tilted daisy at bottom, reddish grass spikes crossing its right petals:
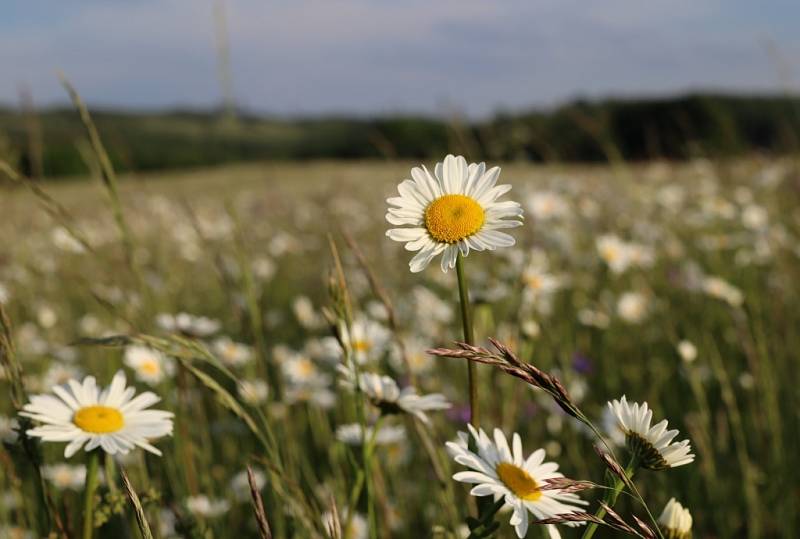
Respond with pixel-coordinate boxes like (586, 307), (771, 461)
(447, 425), (588, 537)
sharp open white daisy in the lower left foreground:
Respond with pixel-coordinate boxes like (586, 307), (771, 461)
(20, 371), (172, 458)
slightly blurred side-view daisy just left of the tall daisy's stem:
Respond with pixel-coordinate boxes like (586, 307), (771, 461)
(339, 372), (451, 424)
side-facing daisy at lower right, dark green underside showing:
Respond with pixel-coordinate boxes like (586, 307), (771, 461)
(608, 396), (694, 470)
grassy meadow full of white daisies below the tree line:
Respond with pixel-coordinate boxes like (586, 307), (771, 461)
(0, 157), (800, 539)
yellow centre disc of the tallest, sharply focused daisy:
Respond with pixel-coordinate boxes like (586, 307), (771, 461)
(425, 195), (485, 243)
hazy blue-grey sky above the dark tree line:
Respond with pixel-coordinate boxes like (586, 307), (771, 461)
(0, 0), (800, 116)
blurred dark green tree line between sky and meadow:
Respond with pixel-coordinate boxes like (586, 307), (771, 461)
(0, 94), (800, 176)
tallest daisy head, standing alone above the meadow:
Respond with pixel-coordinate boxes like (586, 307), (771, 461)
(386, 155), (522, 273)
